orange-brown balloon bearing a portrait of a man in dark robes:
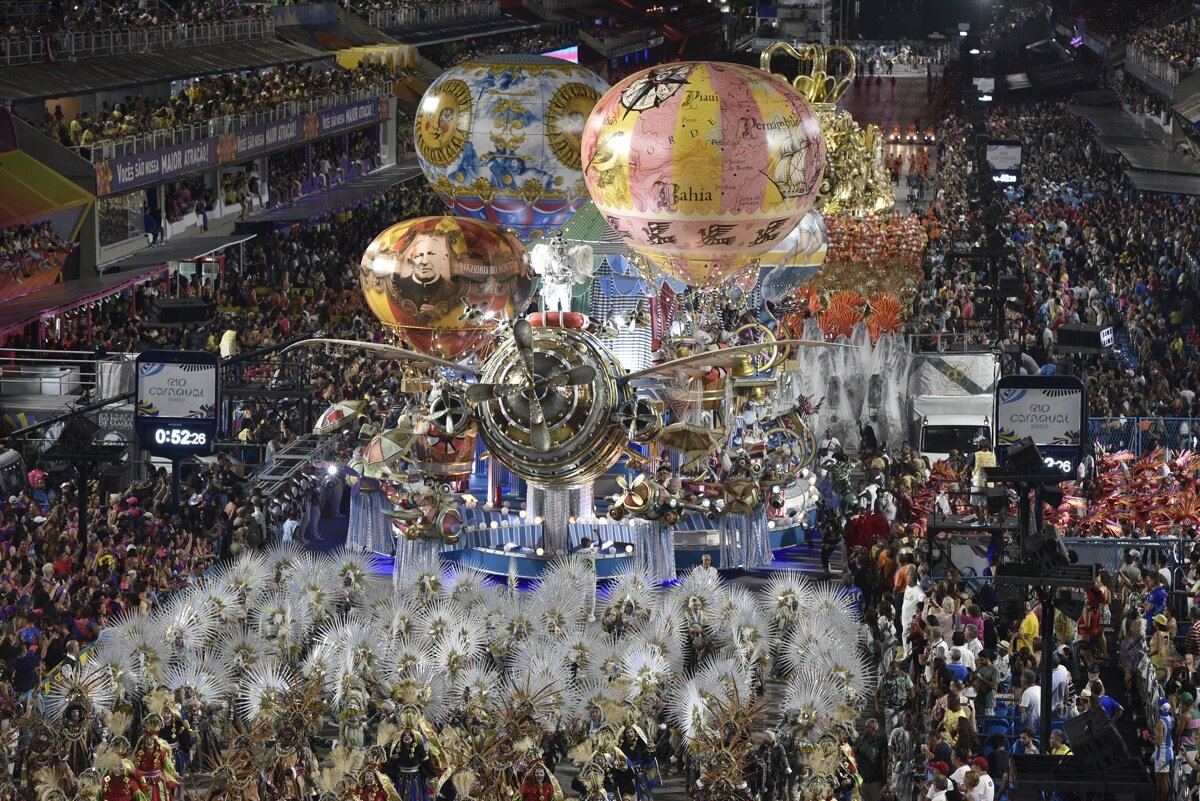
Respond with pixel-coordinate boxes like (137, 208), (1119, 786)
(359, 217), (533, 359)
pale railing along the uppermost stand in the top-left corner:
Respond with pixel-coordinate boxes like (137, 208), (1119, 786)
(0, 17), (275, 66)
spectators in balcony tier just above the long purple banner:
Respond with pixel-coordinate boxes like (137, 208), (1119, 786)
(41, 64), (401, 154)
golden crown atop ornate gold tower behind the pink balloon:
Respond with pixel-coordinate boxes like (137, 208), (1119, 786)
(760, 42), (895, 216)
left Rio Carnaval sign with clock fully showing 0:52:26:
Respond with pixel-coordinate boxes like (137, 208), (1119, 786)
(133, 350), (221, 460)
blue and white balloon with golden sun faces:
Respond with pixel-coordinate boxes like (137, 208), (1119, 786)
(413, 55), (608, 241)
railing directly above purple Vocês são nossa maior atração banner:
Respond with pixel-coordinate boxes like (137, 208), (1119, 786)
(73, 83), (392, 162)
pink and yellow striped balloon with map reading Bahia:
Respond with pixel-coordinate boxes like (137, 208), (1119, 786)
(582, 61), (826, 285)
